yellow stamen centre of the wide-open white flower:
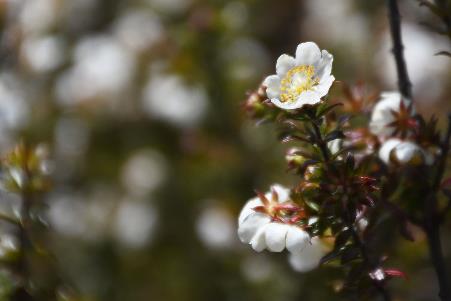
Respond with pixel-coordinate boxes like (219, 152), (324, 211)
(280, 65), (319, 102)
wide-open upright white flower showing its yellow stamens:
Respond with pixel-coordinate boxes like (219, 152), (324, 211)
(263, 42), (335, 110)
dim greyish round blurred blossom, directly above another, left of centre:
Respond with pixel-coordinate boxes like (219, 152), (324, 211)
(121, 149), (167, 196)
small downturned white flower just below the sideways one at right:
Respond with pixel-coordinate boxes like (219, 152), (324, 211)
(379, 138), (434, 165)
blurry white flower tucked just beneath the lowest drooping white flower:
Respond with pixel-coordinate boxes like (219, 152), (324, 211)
(288, 237), (327, 272)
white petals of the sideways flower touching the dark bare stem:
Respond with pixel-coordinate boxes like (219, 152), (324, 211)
(370, 92), (413, 137)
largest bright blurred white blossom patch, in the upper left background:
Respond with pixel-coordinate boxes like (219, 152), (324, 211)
(56, 36), (135, 105)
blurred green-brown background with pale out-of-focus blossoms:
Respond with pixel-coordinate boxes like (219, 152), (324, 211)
(0, 0), (451, 301)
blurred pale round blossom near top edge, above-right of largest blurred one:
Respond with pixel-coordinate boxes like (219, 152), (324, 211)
(114, 10), (164, 52)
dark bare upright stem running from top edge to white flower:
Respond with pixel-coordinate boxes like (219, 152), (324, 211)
(387, 0), (412, 99)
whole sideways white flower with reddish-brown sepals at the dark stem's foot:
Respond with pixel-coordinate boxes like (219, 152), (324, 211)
(369, 92), (414, 137)
